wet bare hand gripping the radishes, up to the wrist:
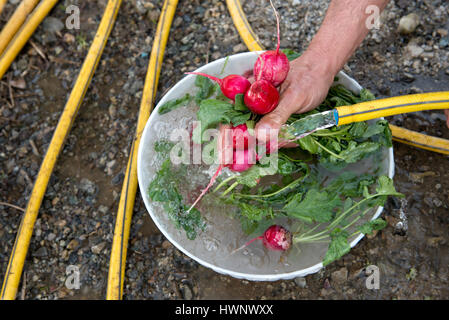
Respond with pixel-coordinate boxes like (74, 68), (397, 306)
(255, 52), (335, 141)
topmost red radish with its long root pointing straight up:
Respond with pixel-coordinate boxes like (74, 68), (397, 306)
(254, 0), (290, 87)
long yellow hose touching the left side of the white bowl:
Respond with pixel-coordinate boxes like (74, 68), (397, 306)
(106, 0), (178, 300)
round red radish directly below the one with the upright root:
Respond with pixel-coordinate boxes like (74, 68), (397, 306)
(244, 79), (279, 114)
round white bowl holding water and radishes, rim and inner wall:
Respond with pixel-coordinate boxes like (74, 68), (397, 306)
(137, 52), (394, 281)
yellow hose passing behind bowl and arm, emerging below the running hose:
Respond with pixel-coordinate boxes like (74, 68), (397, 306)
(226, 0), (449, 154)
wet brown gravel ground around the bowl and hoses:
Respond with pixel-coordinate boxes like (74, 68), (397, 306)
(0, 0), (449, 299)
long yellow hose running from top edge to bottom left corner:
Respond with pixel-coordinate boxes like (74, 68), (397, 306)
(0, 0), (122, 300)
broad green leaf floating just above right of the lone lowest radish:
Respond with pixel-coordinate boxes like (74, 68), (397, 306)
(283, 189), (341, 223)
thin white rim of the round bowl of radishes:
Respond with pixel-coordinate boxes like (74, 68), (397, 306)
(137, 51), (394, 281)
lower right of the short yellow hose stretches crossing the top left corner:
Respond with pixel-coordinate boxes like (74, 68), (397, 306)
(0, 0), (58, 79)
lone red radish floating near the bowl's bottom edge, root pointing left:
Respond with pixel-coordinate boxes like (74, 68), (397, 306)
(231, 224), (292, 254)
